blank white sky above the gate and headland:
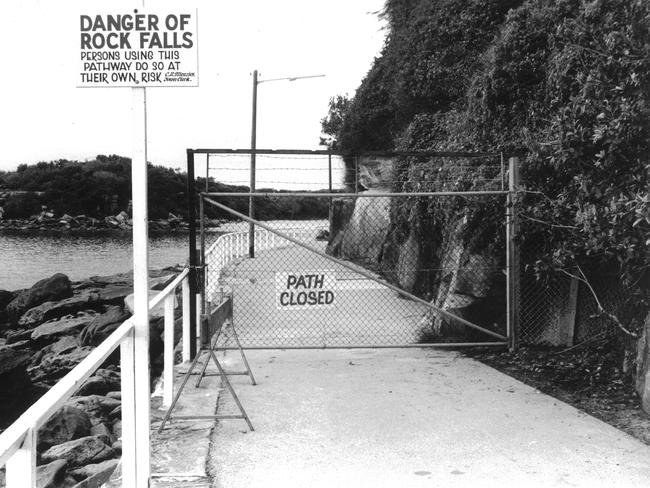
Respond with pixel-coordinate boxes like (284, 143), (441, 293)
(0, 0), (385, 185)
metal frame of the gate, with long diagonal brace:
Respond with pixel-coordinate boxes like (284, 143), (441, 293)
(187, 149), (519, 350)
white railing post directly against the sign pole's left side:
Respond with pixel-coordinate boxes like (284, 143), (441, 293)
(120, 330), (137, 488)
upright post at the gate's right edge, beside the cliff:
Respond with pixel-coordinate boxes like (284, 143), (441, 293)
(506, 158), (520, 351)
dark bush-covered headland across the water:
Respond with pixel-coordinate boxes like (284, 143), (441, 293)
(0, 155), (328, 220)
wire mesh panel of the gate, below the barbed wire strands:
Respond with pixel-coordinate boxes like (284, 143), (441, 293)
(205, 193), (506, 347)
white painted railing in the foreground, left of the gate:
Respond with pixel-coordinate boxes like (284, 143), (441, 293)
(0, 269), (190, 488)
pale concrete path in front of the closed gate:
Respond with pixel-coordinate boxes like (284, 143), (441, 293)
(210, 349), (650, 488)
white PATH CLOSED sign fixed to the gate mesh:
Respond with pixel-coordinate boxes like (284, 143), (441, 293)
(275, 270), (336, 310)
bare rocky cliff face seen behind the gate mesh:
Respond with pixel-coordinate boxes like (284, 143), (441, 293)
(327, 158), (506, 341)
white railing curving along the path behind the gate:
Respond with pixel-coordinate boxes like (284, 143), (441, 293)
(205, 227), (315, 300)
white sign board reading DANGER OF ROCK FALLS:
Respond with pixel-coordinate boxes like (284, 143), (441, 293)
(77, 7), (199, 88)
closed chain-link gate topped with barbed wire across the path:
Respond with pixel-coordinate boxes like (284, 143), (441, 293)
(194, 150), (510, 349)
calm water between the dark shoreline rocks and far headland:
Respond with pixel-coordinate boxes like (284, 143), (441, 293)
(0, 234), (195, 290)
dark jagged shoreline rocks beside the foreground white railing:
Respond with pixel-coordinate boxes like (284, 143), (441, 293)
(0, 268), (180, 488)
